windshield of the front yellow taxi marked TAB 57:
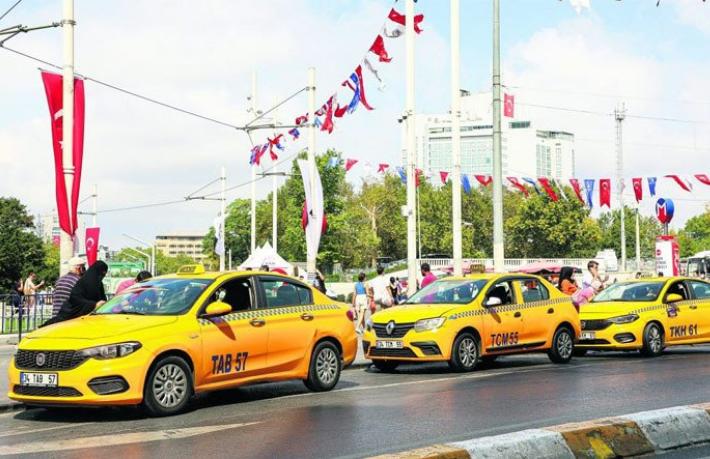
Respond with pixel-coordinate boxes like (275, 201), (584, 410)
(94, 278), (212, 316)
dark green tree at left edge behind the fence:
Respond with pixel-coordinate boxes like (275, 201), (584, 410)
(0, 197), (45, 292)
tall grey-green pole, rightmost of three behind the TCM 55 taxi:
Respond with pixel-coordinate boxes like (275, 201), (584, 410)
(493, 0), (505, 272)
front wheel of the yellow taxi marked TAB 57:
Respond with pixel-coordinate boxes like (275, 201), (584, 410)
(143, 356), (193, 417)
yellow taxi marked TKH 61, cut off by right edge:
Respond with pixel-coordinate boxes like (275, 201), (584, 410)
(578, 277), (710, 357)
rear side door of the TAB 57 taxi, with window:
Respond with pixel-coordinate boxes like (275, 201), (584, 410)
(259, 276), (319, 373)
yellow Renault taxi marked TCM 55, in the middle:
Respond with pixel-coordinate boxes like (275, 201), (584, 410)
(362, 274), (580, 371)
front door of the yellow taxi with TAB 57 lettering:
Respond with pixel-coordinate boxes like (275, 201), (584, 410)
(196, 276), (268, 385)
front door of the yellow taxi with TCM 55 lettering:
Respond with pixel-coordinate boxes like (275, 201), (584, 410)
(481, 279), (523, 353)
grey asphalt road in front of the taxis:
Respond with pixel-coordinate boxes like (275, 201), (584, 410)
(0, 346), (710, 458)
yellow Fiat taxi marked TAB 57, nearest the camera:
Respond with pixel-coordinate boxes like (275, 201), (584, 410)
(8, 265), (357, 416)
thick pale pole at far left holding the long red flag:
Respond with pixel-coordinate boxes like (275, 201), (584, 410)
(59, 0), (76, 275)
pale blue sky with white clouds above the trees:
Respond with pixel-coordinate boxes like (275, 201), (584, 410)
(0, 0), (710, 249)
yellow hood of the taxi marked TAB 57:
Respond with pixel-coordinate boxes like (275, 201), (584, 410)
(26, 314), (178, 340)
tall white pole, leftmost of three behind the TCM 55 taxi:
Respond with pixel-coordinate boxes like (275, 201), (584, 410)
(404, 0), (417, 295)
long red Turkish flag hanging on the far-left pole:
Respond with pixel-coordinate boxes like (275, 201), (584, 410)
(42, 71), (84, 236)
